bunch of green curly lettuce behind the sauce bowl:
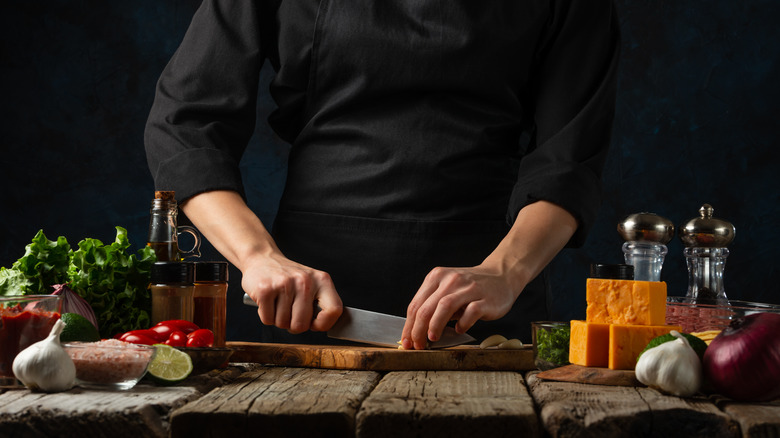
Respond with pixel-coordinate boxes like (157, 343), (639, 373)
(0, 227), (157, 338)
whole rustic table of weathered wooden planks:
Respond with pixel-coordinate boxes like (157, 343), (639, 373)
(0, 364), (780, 438)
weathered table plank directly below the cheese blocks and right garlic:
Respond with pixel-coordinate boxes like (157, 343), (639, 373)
(526, 372), (740, 438)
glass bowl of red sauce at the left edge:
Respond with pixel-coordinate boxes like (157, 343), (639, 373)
(0, 295), (62, 388)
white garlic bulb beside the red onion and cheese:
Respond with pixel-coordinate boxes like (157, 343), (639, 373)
(635, 330), (702, 397)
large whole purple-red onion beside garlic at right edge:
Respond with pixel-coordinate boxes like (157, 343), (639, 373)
(703, 313), (780, 402)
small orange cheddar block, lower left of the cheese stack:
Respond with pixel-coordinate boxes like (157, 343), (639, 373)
(569, 320), (609, 368)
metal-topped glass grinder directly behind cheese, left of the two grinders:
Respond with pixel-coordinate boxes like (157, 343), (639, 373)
(618, 212), (674, 281)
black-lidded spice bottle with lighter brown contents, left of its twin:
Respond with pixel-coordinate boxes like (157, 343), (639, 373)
(150, 262), (195, 325)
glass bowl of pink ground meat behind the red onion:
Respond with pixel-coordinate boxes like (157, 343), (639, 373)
(666, 297), (780, 333)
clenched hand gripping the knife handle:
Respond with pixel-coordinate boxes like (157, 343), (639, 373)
(241, 254), (342, 334)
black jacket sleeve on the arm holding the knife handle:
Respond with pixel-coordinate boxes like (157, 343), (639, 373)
(144, 0), (265, 202)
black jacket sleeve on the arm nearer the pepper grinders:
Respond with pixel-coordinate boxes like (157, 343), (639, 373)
(508, 0), (620, 247)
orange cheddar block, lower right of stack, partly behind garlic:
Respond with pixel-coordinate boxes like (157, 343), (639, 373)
(609, 324), (682, 370)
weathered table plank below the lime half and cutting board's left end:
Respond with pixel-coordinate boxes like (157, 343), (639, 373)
(171, 367), (380, 438)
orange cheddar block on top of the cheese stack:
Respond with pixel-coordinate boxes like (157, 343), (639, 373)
(585, 278), (666, 326)
